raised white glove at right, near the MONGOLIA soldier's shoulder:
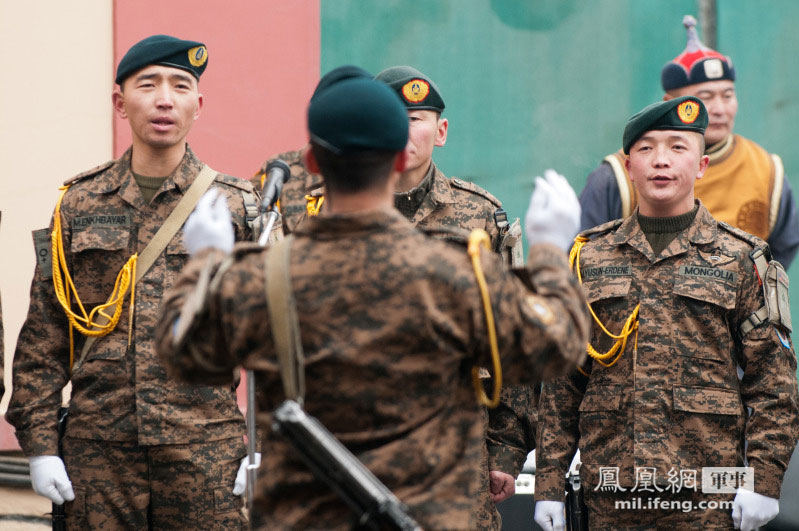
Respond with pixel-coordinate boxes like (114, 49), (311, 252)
(524, 170), (580, 252)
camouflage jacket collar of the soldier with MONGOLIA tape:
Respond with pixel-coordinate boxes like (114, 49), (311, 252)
(610, 199), (718, 262)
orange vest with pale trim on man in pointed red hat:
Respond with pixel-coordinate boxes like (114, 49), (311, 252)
(605, 135), (785, 240)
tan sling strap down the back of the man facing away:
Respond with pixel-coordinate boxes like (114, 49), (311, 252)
(264, 236), (305, 404)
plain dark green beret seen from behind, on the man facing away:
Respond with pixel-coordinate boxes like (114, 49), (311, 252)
(308, 77), (408, 154)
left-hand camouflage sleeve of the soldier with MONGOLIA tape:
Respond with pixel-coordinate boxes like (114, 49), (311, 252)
(535, 371), (588, 502)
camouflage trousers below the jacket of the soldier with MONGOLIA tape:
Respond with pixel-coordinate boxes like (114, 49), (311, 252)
(585, 490), (734, 531)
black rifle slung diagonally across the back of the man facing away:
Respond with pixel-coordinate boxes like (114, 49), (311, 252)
(272, 400), (422, 531)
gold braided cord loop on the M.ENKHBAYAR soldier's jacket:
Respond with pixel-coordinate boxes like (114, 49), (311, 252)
(50, 186), (138, 370)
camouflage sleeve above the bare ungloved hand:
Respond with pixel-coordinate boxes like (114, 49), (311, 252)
(486, 384), (540, 476)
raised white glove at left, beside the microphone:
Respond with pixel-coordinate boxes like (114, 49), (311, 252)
(183, 189), (236, 255)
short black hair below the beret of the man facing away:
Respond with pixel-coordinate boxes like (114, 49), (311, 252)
(311, 140), (398, 194)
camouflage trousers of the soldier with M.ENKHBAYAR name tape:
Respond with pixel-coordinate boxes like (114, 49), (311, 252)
(64, 437), (247, 530)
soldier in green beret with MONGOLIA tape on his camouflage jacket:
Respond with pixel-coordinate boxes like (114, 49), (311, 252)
(535, 96), (799, 530)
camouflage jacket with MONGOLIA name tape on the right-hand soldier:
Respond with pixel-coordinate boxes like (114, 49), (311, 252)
(536, 204), (799, 500)
